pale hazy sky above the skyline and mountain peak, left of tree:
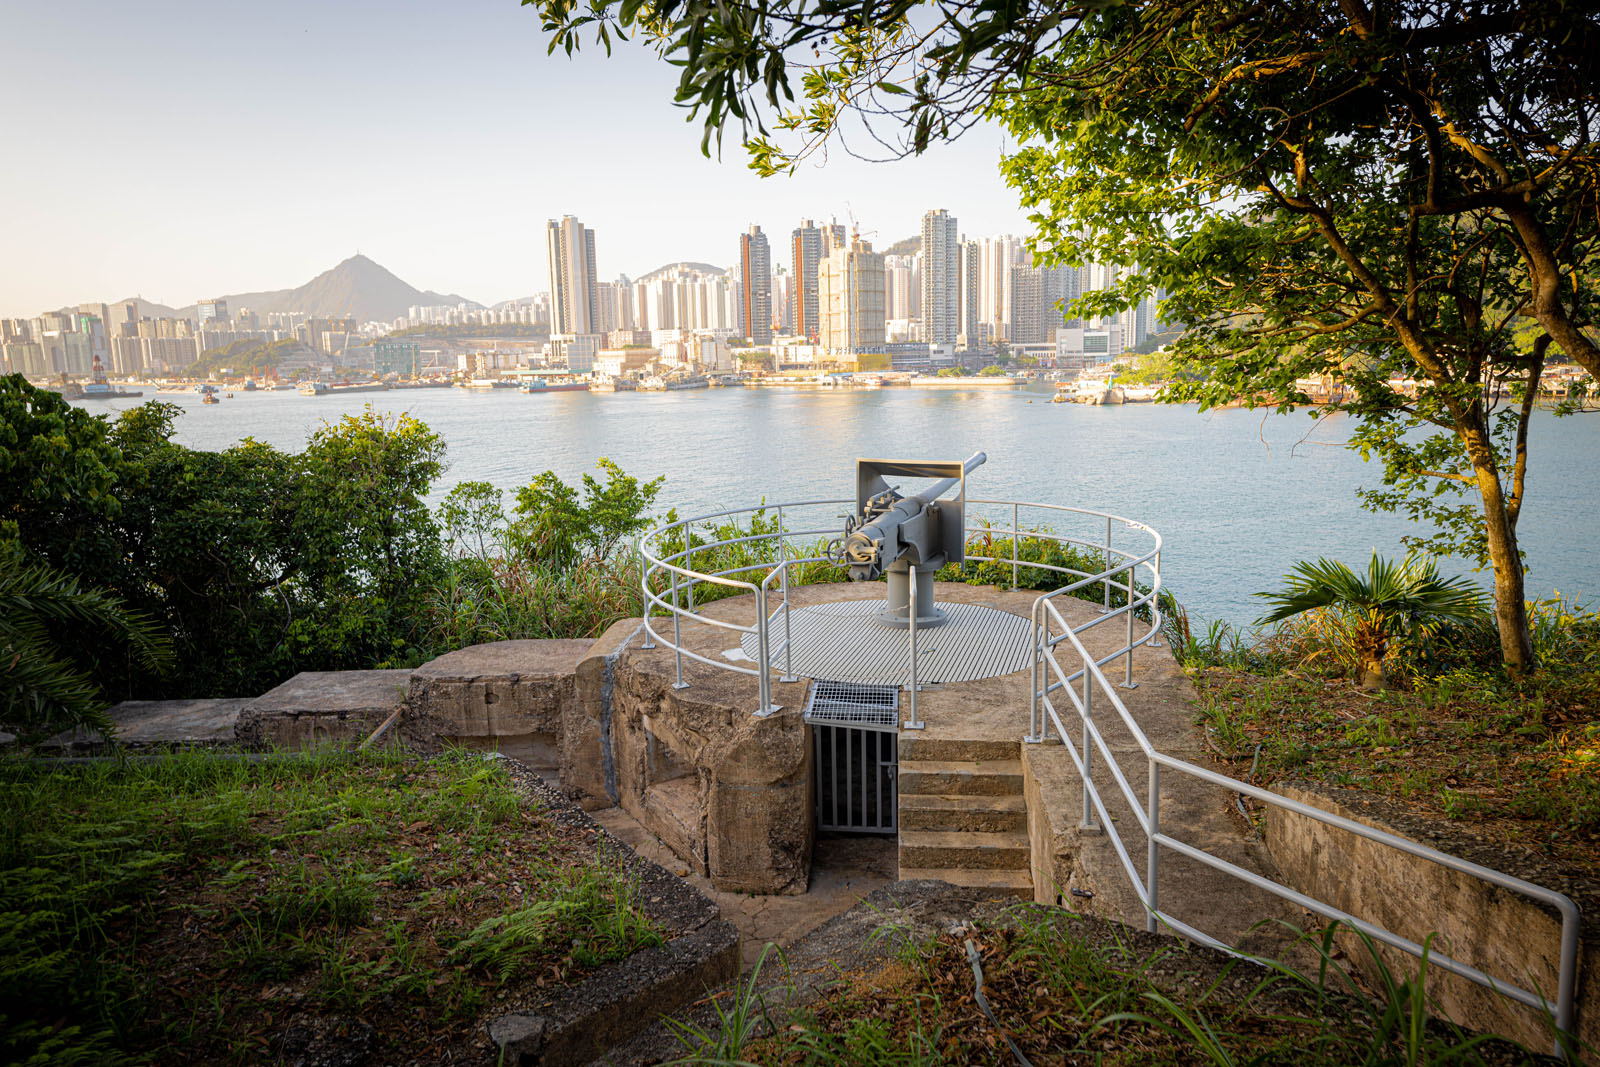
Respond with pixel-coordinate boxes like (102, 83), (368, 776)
(0, 0), (1026, 317)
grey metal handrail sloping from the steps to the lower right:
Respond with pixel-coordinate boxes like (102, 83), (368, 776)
(1026, 585), (1579, 1056)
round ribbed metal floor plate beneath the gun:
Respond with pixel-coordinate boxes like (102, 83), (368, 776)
(741, 600), (1032, 686)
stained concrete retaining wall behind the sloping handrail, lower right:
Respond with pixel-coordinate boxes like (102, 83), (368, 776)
(1266, 787), (1600, 1051)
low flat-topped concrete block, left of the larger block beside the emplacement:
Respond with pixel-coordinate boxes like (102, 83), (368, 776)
(234, 670), (411, 749)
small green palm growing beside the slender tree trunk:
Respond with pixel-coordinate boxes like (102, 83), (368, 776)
(1256, 552), (1485, 688)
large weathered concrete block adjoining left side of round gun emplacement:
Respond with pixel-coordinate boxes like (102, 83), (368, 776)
(406, 640), (592, 768)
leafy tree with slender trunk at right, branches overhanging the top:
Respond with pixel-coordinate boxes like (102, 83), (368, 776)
(530, 0), (1600, 673)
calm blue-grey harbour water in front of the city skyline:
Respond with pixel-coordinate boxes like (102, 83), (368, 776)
(82, 389), (1600, 622)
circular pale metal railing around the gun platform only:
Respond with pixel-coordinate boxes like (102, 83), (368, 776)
(637, 499), (1160, 729)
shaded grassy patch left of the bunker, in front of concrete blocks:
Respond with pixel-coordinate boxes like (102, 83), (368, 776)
(0, 753), (662, 1064)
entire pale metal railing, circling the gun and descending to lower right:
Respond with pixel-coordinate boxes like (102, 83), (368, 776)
(638, 499), (1579, 1054)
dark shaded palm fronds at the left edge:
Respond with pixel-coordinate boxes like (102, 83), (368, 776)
(0, 541), (171, 744)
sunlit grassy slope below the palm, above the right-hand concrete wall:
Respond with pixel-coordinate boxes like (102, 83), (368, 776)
(1174, 601), (1600, 865)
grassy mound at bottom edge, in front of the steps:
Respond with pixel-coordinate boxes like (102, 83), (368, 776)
(674, 905), (1574, 1067)
